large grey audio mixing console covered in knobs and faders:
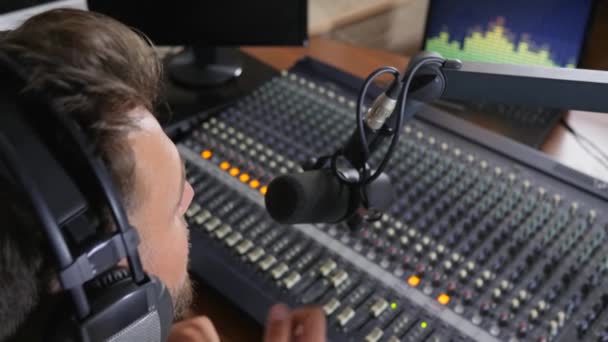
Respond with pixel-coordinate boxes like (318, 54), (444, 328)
(178, 60), (608, 341)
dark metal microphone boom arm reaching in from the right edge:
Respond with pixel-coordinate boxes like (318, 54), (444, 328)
(387, 52), (608, 132)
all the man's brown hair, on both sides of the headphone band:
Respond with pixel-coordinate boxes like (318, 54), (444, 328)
(0, 9), (161, 340)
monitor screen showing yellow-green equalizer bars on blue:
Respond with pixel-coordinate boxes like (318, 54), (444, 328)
(424, 0), (593, 67)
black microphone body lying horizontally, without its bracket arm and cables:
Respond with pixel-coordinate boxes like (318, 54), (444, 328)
(264, 168), (394, 225)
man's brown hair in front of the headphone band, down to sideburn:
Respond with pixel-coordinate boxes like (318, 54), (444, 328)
(0, 9), (161, 207)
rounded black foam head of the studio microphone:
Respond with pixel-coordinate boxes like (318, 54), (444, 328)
(264, 169), (358, 224)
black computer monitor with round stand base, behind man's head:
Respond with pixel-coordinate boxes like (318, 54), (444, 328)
(89, 0), (308, 87)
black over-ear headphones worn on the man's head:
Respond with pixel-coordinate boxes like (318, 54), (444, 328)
(0, 50), (173, 342)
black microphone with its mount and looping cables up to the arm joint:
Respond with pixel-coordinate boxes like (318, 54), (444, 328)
(264, 53), (460, 230)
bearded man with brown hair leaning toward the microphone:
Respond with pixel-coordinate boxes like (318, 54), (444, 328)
(0, 9), (325, 342)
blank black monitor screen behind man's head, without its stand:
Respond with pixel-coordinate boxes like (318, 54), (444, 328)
(89, 0), (307, 46)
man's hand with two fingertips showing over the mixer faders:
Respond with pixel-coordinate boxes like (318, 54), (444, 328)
(264, 304), (325, 342)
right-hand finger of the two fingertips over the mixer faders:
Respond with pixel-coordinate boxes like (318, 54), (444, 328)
(291, 307), (326, 342)
